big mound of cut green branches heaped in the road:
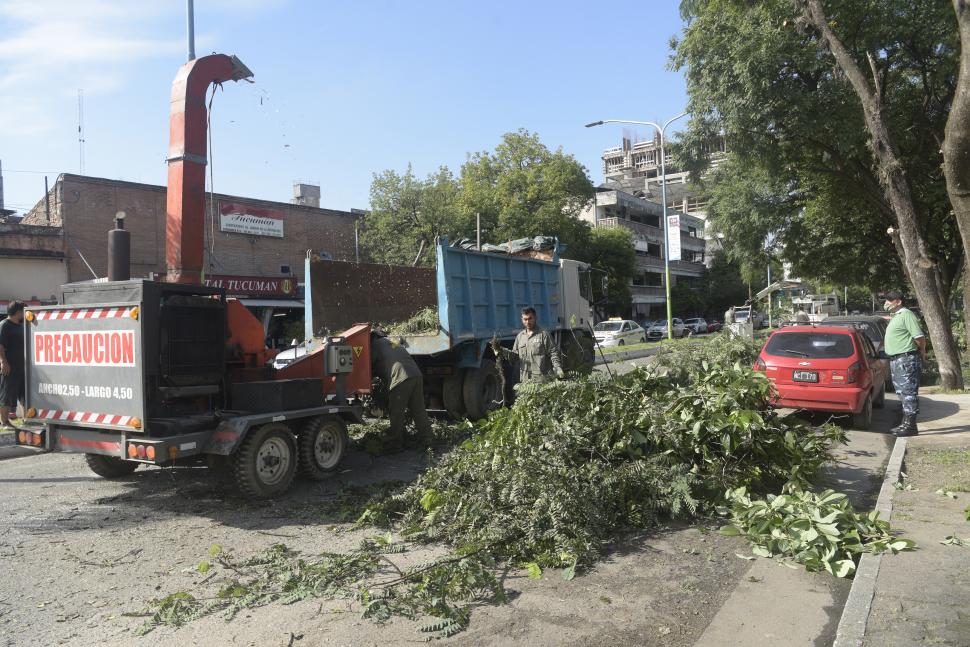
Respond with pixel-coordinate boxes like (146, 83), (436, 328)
(363, 338), (844, 569)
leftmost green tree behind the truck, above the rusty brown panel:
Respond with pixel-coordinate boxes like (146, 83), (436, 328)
(361, 164), (475, 266)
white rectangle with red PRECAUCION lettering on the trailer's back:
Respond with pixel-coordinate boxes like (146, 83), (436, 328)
(33, 330), (135, 367)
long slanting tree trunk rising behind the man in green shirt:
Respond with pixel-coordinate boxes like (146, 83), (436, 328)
(794, 0), (963, 390)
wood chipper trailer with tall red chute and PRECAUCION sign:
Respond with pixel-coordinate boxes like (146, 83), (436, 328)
(17, 54), (371, 498)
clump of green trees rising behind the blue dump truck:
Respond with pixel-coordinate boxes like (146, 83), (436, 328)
(362, 130), (636, 310)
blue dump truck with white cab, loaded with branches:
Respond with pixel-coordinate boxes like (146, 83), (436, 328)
(304, 237), (594, 420)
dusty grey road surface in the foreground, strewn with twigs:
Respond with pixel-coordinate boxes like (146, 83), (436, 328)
(0, 451), (750, 647)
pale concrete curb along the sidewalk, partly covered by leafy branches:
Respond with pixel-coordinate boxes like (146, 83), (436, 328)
(832, 438), (907, 647)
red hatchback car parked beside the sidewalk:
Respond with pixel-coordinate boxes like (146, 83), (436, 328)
(754, 325), (889, 429)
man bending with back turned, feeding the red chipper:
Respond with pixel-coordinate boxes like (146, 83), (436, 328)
(370, 333), (431, 445)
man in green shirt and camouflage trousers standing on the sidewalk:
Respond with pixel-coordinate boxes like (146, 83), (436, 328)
(885, 292), (926, 436)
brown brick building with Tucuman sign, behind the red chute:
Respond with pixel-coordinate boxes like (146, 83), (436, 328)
(23, 173), (359, 282)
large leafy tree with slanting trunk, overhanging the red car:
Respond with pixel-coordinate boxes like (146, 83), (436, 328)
(673, 0), (964, 387)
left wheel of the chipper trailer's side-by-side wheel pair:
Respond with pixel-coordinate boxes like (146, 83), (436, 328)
(232, 423), (297, 499)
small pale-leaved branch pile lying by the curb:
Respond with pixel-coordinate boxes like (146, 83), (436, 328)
(721, 487), (916, 577)
